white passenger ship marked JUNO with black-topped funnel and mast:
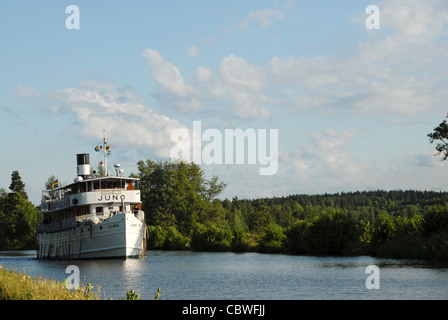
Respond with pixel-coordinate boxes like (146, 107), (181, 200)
(37, 132), (146, 259)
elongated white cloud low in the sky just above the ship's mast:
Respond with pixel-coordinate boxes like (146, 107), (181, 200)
(17, 81), (188, 158)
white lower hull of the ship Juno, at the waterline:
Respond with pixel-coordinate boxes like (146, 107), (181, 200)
(37, 213), (146, 259)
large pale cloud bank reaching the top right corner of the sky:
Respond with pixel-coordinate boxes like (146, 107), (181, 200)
(262, 0), (448, 115)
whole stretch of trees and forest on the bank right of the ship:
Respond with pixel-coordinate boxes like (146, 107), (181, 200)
(136, 160), (448, 260)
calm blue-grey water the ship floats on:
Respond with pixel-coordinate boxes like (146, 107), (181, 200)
(0, 251), (448, 300)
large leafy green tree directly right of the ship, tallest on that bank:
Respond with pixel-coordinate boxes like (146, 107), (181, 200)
(135, 160), (225, 235)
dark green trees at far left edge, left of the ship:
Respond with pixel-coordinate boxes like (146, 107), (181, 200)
(0, 171), (37, 250)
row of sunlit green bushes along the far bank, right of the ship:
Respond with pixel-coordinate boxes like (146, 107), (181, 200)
(147, 195), (448, 262)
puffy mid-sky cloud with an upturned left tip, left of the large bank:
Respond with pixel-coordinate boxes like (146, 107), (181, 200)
(143, 49), (270, 118)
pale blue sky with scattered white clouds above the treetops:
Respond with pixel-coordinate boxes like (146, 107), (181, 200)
(0, 0), (448, 204)
